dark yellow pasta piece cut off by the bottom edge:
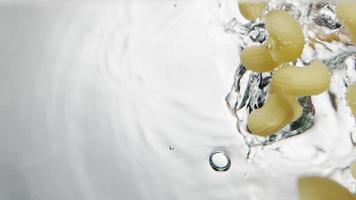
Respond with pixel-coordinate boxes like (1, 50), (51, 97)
(298, 176), (355, 200)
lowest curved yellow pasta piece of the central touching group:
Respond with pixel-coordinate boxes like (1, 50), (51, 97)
(247, 94), (294, 136)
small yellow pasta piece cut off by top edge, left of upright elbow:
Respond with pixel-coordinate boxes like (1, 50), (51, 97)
(238, 0), (267, 21)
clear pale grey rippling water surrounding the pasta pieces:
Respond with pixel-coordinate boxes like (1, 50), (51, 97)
(0, 0), (356, 200)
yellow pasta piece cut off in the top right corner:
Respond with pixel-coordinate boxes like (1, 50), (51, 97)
(336, 0), (356, 44)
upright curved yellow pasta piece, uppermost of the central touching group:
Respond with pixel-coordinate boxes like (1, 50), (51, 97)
(265, 10), (304, 63)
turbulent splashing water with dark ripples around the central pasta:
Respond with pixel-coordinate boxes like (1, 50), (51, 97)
(225, 1), (356, 148)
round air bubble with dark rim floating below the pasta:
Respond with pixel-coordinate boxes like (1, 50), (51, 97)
(209, 151), (231, 172)
